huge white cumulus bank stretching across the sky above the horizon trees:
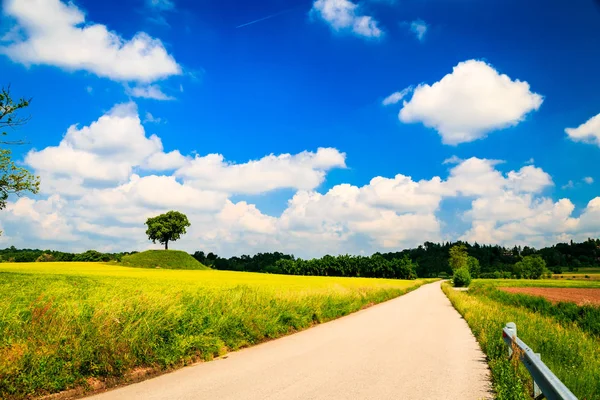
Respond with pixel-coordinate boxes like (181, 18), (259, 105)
(2, 103), (600, 257)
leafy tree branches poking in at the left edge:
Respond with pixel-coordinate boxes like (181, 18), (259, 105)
(0, 87), (40, 234)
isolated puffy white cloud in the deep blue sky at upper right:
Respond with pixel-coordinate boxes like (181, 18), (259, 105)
(399, 60), (543, 145)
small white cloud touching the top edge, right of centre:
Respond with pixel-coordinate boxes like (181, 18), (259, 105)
(311, 0), (383, 38)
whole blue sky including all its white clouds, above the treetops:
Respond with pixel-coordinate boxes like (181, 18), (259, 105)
(0, 0), (600, 256)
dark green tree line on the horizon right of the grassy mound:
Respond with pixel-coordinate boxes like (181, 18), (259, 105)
(192, 239), (600, 278)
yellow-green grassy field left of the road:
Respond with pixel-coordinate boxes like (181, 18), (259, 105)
(0, 263), (426, 399)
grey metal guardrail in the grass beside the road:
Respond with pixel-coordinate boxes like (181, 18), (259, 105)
(502, 322), (577, 400)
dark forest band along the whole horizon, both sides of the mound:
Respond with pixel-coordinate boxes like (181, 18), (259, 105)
(0, 239), (600, 279)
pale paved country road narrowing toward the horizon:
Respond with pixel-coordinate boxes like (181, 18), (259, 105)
(91, 282), (491, 400)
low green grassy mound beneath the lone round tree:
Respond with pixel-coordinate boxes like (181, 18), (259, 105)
(121, 250), (209, 269)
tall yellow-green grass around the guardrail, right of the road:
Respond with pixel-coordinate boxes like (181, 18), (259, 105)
(442, 284), (600, 400)
